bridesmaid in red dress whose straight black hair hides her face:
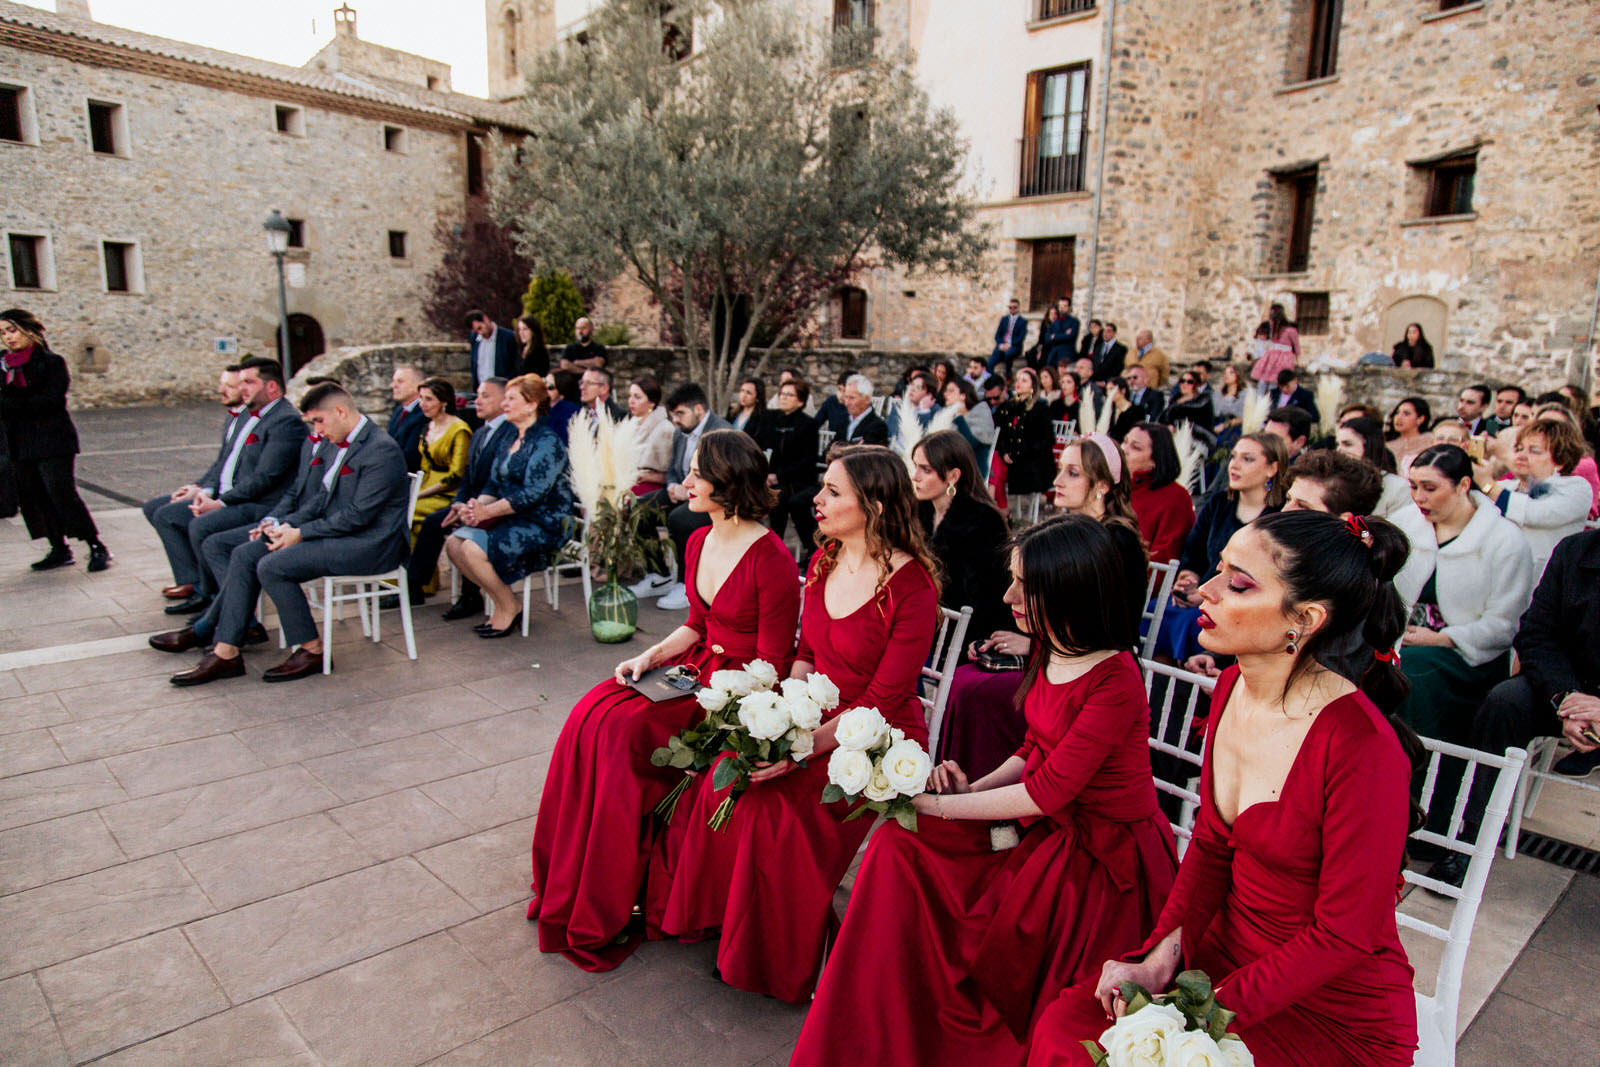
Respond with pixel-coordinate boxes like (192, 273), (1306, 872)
(790, 511), (1178, 1067)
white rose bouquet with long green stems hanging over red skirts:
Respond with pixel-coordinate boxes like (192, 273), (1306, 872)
(650, 659), (838, 830)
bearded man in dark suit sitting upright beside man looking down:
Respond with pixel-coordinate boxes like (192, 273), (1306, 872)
(157, 360), (306, 614)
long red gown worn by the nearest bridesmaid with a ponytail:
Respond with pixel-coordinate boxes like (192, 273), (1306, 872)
(1029, 667), (1416, 1067)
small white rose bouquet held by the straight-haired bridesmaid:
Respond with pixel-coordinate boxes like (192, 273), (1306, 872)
(822, 707), (933, 832)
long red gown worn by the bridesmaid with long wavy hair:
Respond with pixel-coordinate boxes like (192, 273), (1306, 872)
(645, 553), (939, 1003)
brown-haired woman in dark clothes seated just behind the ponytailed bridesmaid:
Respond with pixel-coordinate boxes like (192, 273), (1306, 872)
(1157, 434), (1290, 664)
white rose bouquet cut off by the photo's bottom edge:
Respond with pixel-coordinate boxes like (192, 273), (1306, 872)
(1083, 971), (1256, 1067)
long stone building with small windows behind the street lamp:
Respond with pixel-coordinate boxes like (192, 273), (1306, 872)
(0, 0), (515, 403)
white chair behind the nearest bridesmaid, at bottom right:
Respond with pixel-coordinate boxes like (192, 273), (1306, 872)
(1395, 737), (1528, 1067)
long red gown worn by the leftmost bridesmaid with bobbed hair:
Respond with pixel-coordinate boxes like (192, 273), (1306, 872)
(528, 526), (800, 971)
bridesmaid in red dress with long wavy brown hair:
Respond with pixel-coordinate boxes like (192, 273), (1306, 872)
(646, 445), (939, 1003)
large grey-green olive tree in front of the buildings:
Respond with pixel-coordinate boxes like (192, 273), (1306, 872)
(493, 0), (986, 406)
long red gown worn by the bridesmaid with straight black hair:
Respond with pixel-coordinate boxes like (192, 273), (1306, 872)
(790, 653), (1178, 1067)
